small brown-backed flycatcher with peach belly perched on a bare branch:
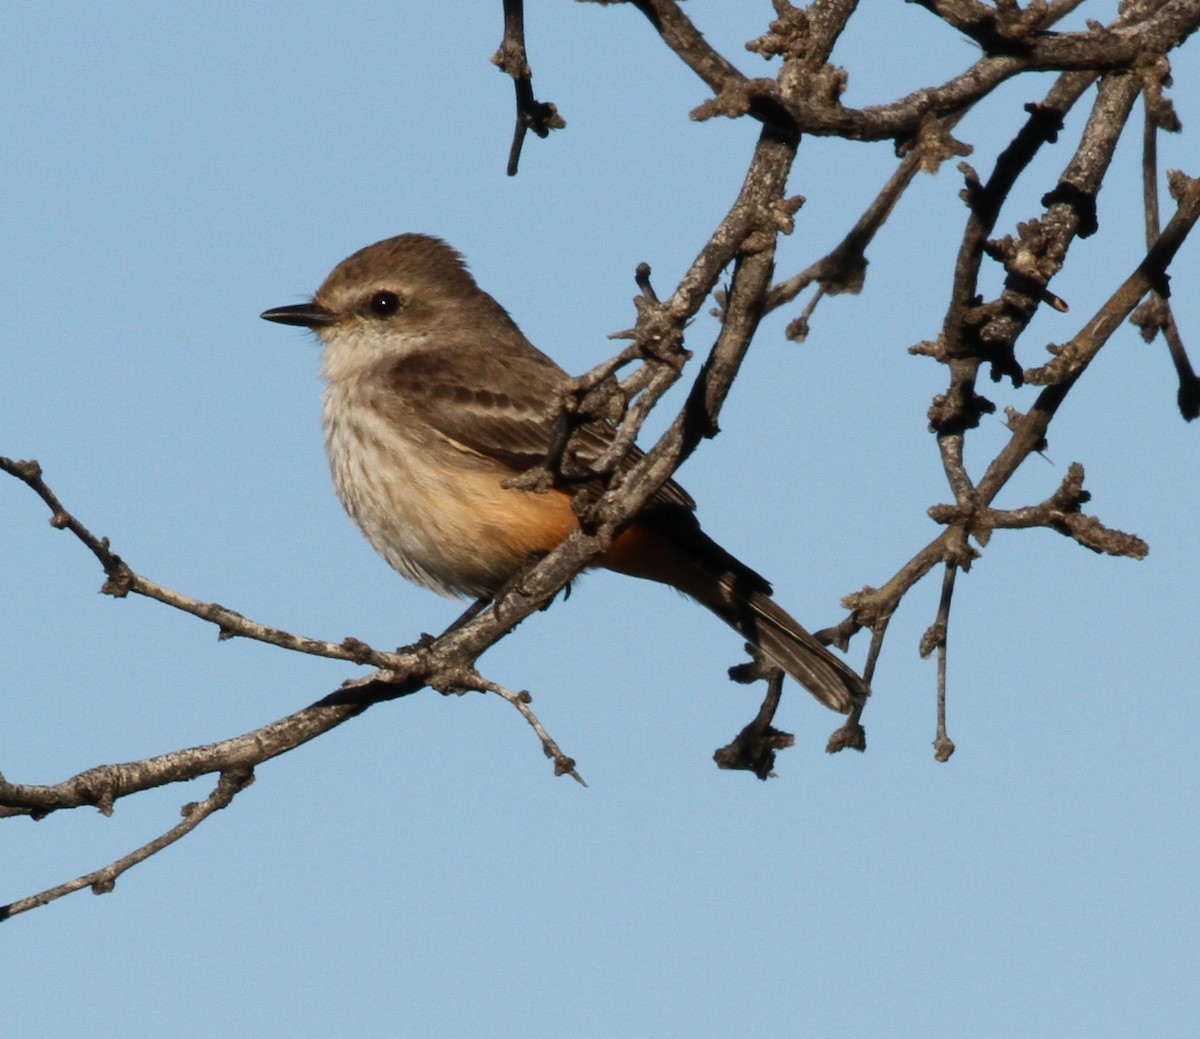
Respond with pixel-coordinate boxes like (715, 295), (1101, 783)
(263, 234), (870, 713)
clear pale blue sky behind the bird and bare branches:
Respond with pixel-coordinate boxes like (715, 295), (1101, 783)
(0, 0), (1200, 1039)
